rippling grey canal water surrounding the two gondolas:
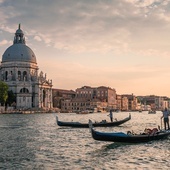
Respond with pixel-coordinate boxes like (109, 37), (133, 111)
(0, 112), (170, 170)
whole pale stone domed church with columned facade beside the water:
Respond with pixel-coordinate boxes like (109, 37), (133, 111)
(0, 24), (52, 110)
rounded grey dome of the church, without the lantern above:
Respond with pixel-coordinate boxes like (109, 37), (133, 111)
(2, 44), (37, 63)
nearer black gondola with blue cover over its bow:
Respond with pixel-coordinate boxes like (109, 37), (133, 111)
(89, 119), (170, 143)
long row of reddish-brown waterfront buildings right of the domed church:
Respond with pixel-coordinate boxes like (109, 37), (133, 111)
(53, 86), (170, 112)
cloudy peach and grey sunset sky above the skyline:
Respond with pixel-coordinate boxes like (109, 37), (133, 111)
(0, 0), (170, 97)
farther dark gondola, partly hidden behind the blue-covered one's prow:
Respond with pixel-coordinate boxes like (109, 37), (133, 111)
(56, 114), (131, 128)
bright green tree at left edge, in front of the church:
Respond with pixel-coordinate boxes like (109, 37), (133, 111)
(0, 81), (8, 105)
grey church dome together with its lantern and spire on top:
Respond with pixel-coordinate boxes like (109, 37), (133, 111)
(2, 25), (37, 63)
